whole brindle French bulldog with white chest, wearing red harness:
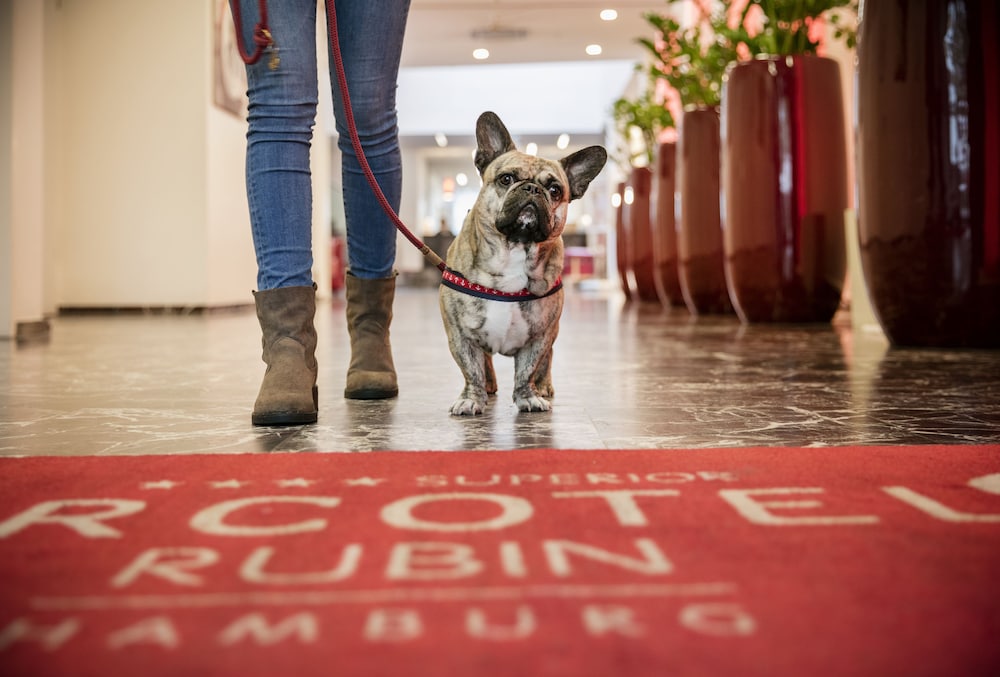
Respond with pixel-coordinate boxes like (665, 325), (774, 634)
(439, 112), (608, 416)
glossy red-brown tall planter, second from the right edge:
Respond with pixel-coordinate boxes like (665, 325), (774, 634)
(722, 55), (848, 322)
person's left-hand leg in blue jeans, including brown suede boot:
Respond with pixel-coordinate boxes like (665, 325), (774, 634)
(233, 0), (317, 425)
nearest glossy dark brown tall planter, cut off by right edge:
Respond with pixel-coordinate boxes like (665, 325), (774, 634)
(857, 0), (1000, 348)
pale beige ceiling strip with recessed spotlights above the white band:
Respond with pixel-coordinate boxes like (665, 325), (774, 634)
(403, 0), (666, 68)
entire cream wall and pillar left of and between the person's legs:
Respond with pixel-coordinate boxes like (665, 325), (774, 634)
(0, 0), (300, 322)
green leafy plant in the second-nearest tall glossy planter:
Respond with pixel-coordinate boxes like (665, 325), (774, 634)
(740, 0), (858, 55)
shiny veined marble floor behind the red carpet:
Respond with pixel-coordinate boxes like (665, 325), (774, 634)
(0, 288), (1000, 455)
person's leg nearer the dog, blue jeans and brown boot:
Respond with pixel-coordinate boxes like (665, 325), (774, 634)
(330, 0), (409, 399)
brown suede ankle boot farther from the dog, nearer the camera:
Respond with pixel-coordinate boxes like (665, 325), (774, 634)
(251, 284), (318, 425)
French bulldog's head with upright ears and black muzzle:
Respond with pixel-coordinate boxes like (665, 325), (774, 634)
(476, 113), (607, 244)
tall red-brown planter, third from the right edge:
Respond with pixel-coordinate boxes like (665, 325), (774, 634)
(677, 107), (733, 315)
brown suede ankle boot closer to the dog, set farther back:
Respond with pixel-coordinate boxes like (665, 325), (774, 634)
(344, 273), (399, 400)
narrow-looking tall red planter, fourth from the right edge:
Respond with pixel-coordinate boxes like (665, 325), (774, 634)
(650, 142), (684, 309)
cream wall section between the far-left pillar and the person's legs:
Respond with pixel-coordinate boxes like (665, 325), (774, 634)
(49, 0), (253, 307)
